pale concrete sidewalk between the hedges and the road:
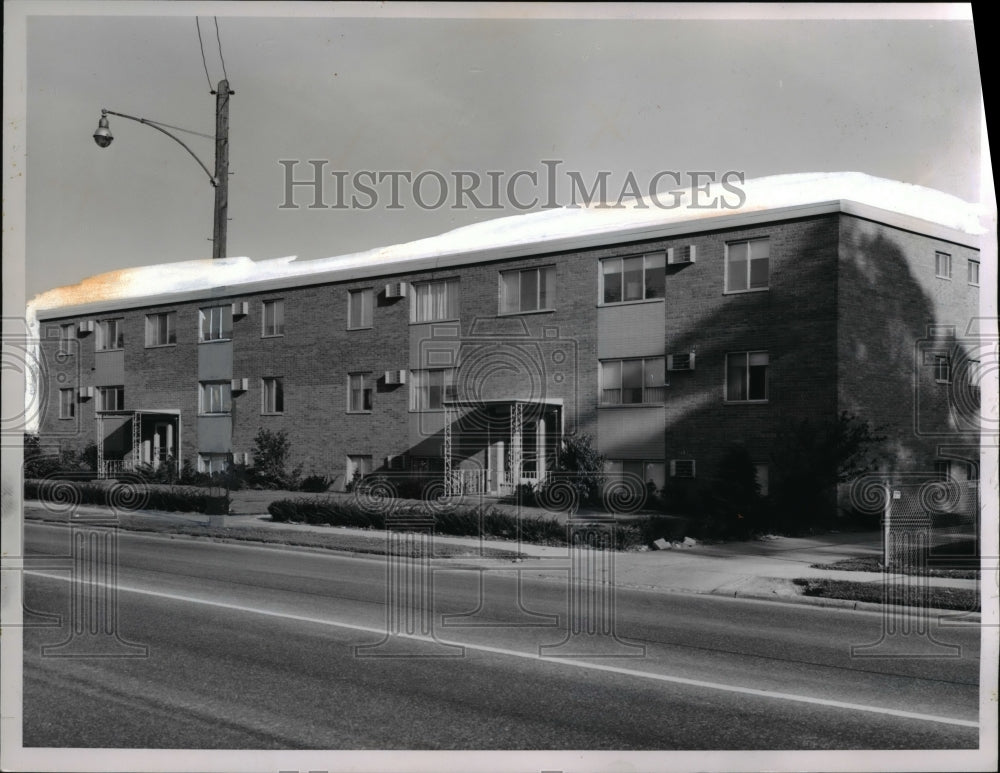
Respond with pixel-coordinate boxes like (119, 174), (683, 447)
(47, 508), (979, 606)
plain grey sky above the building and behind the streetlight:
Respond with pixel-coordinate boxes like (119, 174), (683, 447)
(5, 2), (981, 299)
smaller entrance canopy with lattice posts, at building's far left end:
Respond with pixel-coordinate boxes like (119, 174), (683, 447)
(96, 408), (181, 478)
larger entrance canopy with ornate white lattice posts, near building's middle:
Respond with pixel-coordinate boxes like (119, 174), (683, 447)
(443, 400), (563, 496)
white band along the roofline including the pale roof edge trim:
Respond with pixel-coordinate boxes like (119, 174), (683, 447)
(28, 172), (985, 319)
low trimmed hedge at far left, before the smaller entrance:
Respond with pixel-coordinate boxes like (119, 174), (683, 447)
(24, 479), (229, 514)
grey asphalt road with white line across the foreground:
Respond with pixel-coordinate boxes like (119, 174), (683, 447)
(17, 522), (979, 750)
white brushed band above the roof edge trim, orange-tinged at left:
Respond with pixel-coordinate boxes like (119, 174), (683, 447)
(28, 172), (985, 319)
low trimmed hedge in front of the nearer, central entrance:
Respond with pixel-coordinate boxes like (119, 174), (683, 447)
(267, 498), (645, 550)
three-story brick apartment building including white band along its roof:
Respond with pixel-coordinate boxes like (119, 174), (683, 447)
(31, 174), (979, 516)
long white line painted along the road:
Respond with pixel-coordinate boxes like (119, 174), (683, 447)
(24, 570), (979, 728)
